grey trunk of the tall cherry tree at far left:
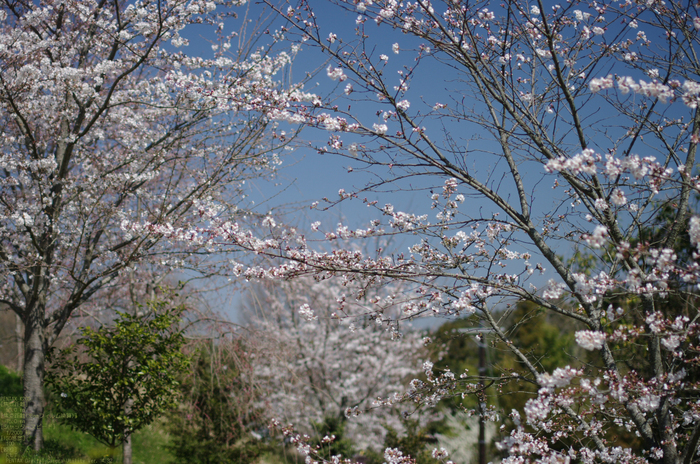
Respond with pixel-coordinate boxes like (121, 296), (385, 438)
(24, 304), (46, 451)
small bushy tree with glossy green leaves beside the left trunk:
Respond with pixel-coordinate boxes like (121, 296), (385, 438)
(46, 300), (189, 447)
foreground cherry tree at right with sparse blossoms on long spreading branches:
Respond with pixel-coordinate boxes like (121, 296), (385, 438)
(194, 0), (700, 464)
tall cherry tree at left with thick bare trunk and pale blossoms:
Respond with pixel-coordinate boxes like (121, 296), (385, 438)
(0, 0), (308, 449)
